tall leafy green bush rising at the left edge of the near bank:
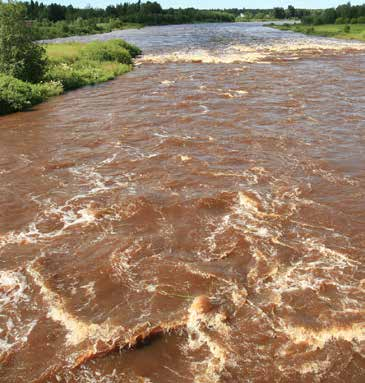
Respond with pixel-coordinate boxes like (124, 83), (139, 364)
(0, 2), (47, 82)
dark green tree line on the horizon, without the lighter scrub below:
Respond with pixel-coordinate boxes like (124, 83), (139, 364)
(14, 0), (365, 25)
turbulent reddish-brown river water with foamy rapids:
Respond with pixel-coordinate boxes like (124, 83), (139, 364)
(0, 23), (365, 383)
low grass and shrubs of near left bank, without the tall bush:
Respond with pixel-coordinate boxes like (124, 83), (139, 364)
(0, 39), (141, 115)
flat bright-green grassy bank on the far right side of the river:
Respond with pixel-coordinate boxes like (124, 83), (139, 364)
(269, 24), (365, 41)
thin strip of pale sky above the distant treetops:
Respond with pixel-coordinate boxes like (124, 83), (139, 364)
(35, 0), (365, 9)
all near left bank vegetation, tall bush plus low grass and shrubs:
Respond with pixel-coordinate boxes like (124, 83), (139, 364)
(0, 2), (141, 115)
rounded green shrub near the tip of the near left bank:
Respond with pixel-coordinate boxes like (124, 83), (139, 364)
(81, 40), (132, 64)
